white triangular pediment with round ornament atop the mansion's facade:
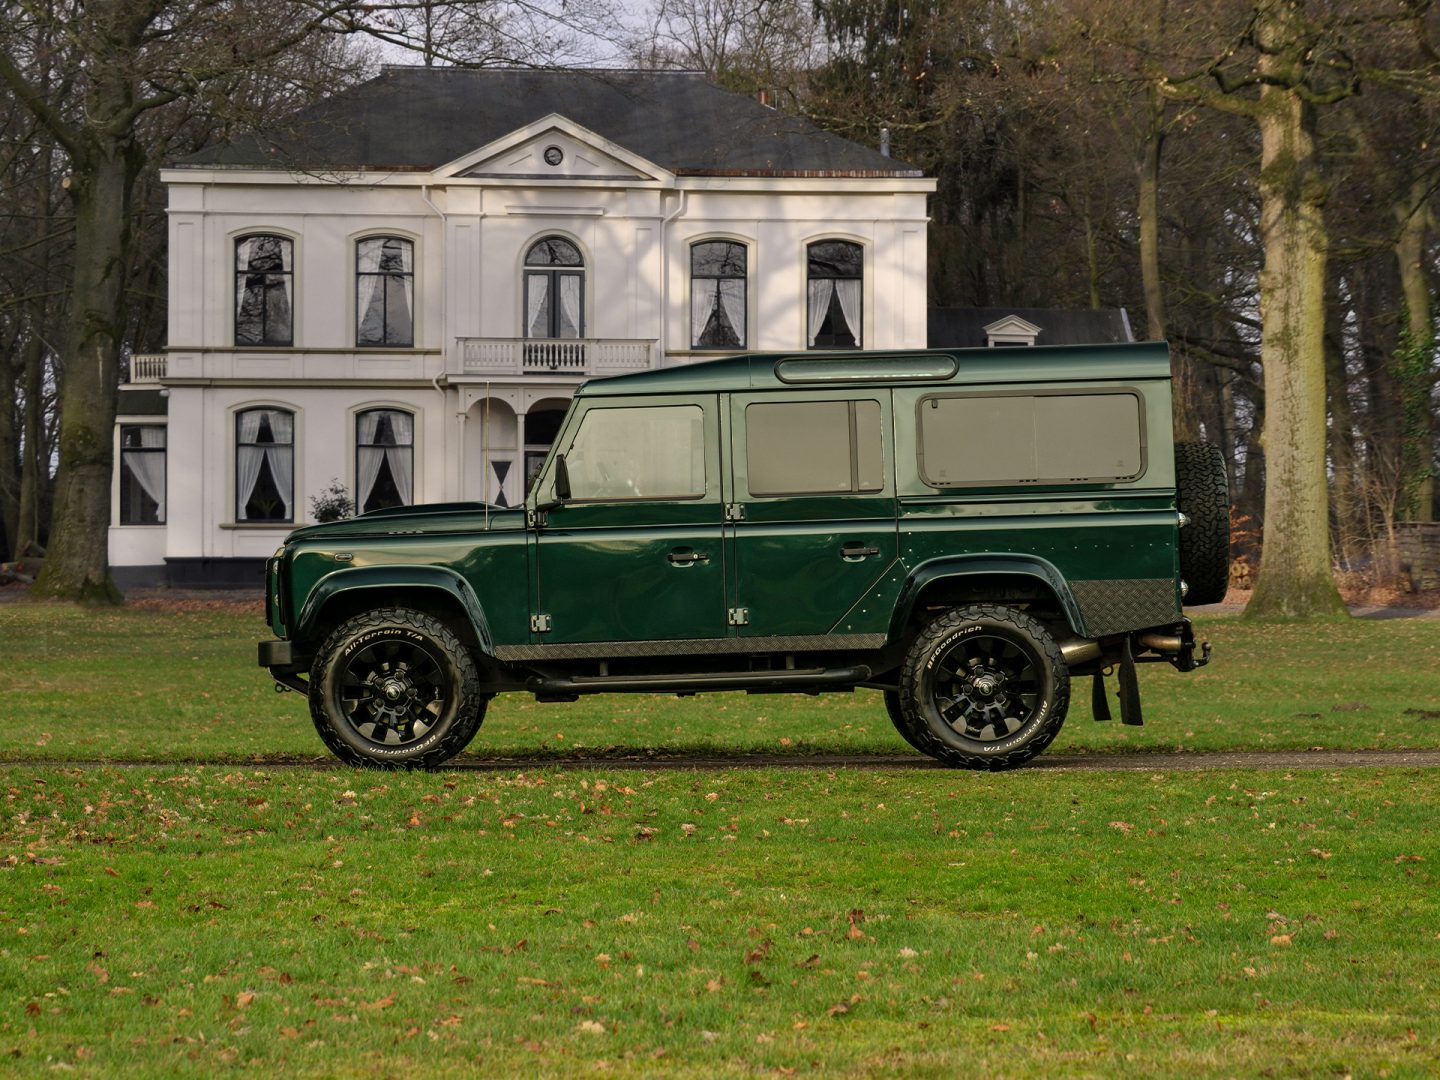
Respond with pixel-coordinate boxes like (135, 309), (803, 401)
(438, 112), (674, 184)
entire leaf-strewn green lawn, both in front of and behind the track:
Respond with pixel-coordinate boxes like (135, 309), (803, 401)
(0, 603), (1440, 1077)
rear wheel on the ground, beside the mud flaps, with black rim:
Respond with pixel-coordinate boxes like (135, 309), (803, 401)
(899, 603), (1070, 770)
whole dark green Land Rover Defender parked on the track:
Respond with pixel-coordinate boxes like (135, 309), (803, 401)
(259, 344), (1230, 769)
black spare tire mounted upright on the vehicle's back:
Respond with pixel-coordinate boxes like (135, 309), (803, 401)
(1175, 442), (1230, 603)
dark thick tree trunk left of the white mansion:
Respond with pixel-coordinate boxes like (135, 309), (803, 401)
(35, 137), (141, 603)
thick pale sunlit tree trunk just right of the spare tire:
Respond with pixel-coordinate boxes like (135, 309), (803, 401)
(1246, 78), (1345, 616)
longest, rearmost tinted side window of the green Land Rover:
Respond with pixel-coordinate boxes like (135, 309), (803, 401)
(919, 390), (1145, 488)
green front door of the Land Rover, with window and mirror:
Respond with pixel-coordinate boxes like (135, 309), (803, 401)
(531, 395), (727, 645)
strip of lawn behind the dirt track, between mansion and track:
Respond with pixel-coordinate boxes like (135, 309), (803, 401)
(0, 603), (1440, 760)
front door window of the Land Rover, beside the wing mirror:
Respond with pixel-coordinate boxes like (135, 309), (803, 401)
(564, 405), (706, 501)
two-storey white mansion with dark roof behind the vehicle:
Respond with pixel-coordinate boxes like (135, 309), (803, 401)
(118, 68), (935, 585)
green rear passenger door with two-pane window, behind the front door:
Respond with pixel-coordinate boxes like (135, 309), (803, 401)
(730, 390), (899, 636)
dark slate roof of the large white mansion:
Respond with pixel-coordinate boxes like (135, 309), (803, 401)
(177, 68), (920, 177)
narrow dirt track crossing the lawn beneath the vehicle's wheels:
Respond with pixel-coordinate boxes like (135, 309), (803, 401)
(8, 750), (1440, 773)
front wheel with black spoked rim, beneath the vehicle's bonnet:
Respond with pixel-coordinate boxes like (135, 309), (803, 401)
(310, 608), (490, 769)
